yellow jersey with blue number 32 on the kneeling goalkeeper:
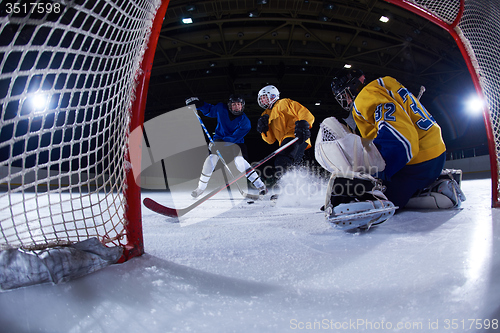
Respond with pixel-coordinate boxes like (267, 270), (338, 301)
(352, 76), (446, 177)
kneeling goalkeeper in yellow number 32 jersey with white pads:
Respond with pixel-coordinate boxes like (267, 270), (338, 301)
(315, 69), (465, 229)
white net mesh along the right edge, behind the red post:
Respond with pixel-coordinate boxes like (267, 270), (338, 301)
(400, 0), (500, 205)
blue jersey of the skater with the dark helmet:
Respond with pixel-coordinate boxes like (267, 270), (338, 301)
(198, 103), (252, 143)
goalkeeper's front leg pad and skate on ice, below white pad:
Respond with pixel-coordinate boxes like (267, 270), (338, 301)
(324, 172), (398, 230)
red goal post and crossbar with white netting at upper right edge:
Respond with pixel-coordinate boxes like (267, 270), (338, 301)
(386, 0), (500, 207)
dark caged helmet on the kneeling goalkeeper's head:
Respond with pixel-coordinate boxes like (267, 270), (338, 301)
(332, 69), (365, 111)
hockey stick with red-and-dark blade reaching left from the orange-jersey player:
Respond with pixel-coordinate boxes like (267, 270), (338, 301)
(143, 138), (298, 217)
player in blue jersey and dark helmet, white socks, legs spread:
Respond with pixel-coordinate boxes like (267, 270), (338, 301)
(186, 94), (267, 198)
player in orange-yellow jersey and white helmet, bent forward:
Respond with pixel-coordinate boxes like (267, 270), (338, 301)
(257, 85), (314, 182)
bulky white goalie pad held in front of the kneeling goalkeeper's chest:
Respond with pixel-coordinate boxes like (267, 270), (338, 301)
(314, 117), (385, 174)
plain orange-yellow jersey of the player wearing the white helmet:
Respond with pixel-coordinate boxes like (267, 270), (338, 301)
(262, 98), (314, 149)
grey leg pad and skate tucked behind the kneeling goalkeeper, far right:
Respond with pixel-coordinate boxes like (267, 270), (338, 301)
(405, 169), (466, 209)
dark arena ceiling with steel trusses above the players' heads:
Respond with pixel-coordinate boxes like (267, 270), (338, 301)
(145, 0), (480, 154)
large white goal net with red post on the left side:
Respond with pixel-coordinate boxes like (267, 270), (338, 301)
(0, 0), (168, 260)
